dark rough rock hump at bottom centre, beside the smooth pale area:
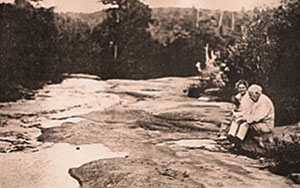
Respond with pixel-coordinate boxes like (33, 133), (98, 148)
(69, 159), (205, 188)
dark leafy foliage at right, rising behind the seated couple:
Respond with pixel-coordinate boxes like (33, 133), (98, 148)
(227, 0), (300, 124)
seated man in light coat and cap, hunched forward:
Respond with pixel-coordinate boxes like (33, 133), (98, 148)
(228, 85), (275, 145)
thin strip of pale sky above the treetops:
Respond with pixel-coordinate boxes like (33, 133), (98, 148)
(0, 0), (280, 13)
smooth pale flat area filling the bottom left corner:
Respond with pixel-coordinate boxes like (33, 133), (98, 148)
(0, 143), (127, 188)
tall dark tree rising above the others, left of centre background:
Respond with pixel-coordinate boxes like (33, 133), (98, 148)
(92, 0), (159, 78)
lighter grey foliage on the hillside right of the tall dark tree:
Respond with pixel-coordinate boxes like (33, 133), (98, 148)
(149, 8), (251, 45)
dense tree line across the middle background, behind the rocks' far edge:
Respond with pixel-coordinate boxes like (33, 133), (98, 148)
(53, 3), (249, 79)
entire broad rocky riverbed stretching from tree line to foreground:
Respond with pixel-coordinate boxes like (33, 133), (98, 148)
(0, 75), (299, 188)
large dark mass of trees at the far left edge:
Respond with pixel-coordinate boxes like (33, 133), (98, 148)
(0, 1), (59, 91)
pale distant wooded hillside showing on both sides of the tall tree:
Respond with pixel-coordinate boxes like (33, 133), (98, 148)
(59, 8), (252, 39)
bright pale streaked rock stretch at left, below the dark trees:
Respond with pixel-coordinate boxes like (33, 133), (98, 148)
(0, 75), (119, 153)
